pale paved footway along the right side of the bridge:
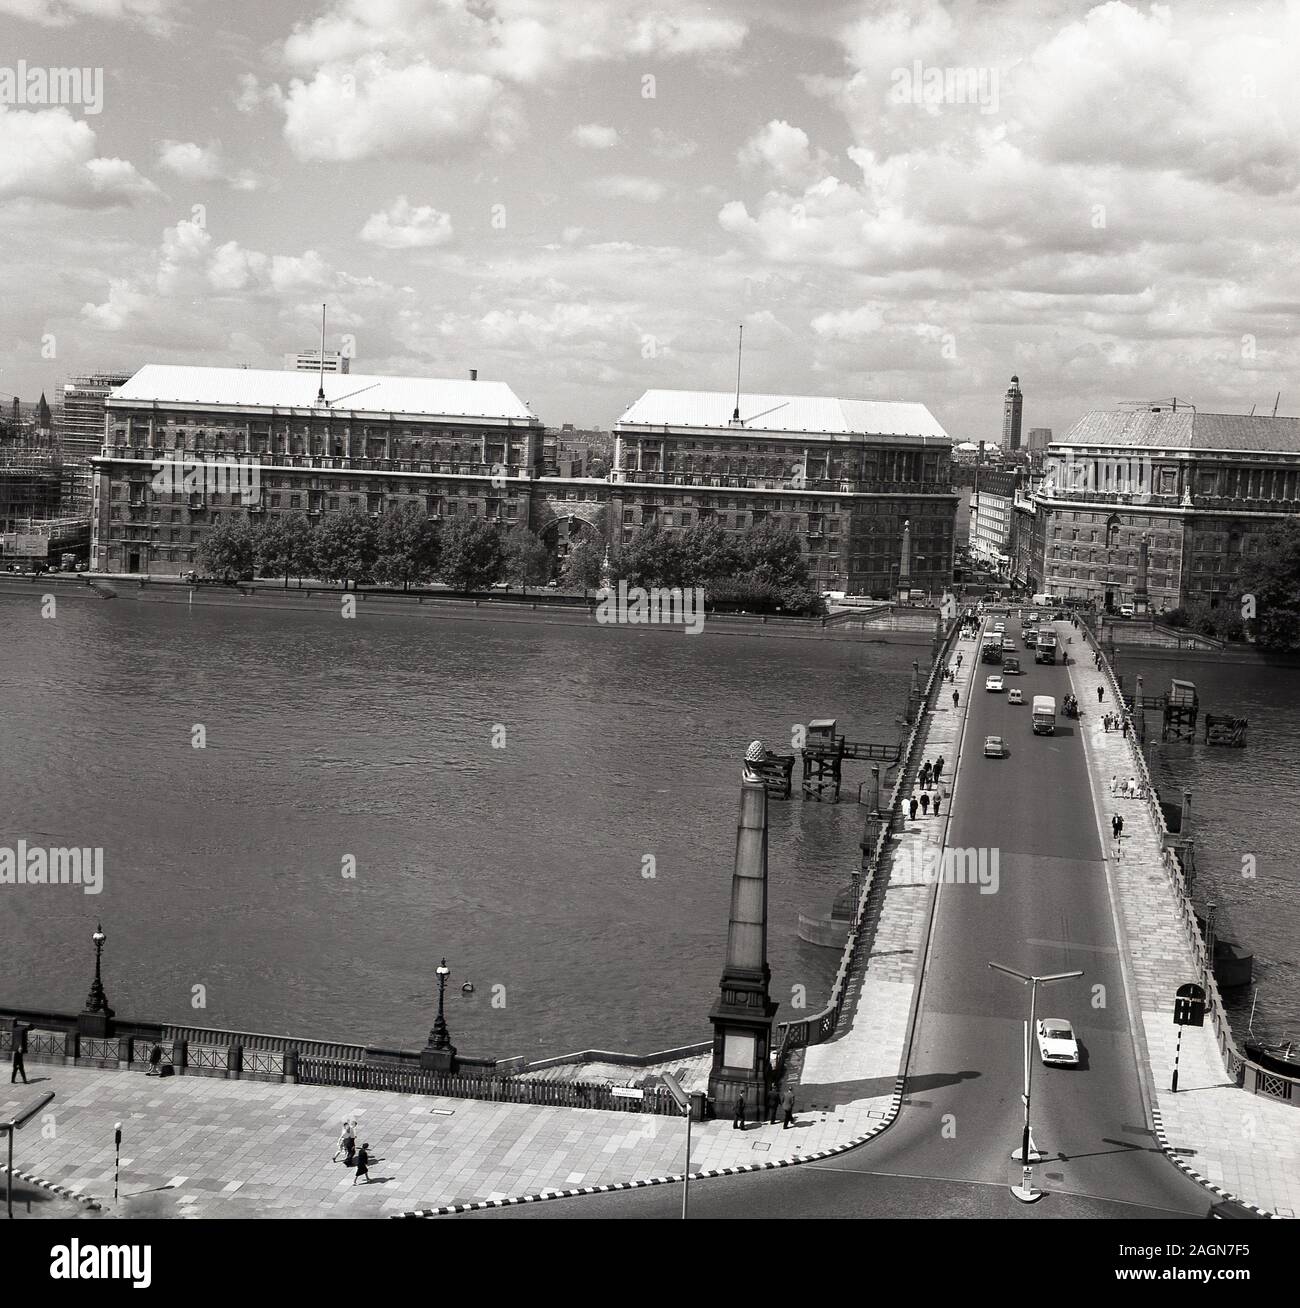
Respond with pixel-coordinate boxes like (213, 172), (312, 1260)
(1055, 623), (1300, 1218)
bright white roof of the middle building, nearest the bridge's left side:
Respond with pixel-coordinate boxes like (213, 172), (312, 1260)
(617, 391), (948, 441)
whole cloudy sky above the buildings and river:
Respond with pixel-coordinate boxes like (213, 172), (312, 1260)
(0, 0), (1300, 439)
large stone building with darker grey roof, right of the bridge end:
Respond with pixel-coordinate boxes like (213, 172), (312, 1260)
(1035, 404), (1300, 611)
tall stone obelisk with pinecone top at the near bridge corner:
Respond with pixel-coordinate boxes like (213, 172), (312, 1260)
(709, 740), (777, 1120)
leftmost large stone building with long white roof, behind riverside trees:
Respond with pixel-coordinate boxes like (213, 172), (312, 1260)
(92, 364), (553, 574)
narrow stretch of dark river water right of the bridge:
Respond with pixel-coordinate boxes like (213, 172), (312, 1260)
(1117, 659), (1300, 1039)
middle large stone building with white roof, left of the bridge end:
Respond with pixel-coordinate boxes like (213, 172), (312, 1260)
(611, 390), (957, 595)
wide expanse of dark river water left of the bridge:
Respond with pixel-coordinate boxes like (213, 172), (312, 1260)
(0, 594), (922, 1057)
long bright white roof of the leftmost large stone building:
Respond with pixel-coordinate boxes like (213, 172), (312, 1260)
(109, 364), (536, 421)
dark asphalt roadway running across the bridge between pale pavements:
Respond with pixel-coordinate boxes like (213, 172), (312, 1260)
(455, 620), (1211, 1218)
